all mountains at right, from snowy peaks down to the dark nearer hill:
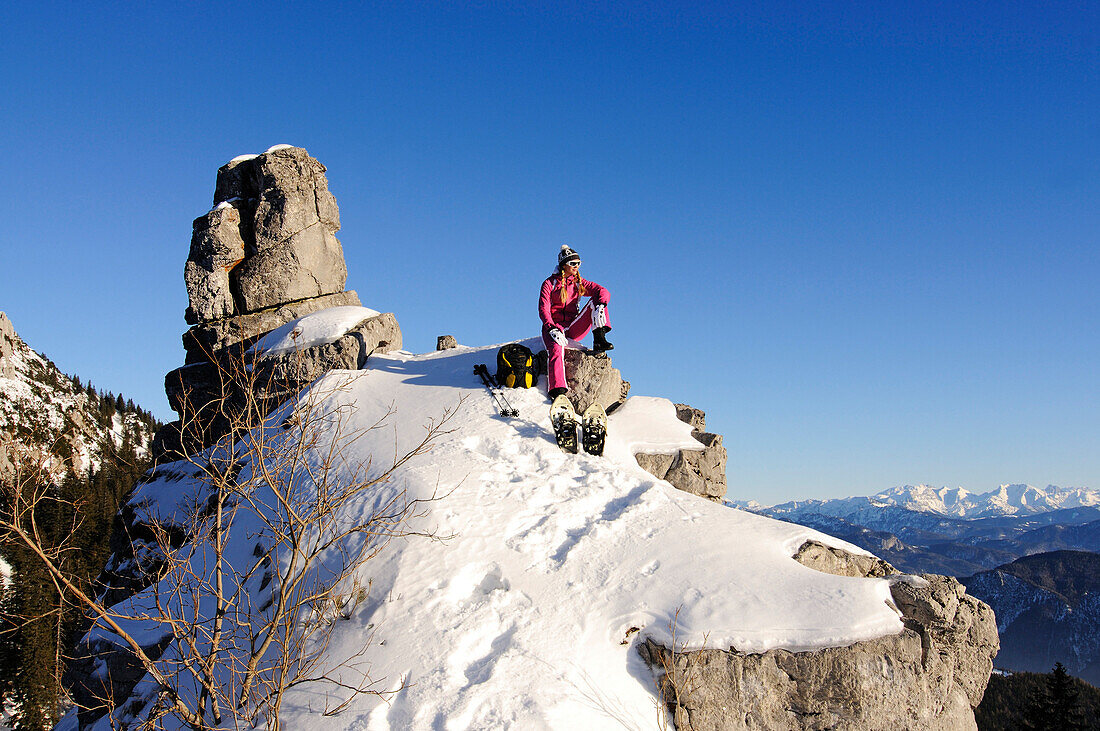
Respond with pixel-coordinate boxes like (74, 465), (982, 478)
(735, 485), (1100, 684)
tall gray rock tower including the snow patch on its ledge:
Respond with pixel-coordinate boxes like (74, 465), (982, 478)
(165, 145), (385, 454)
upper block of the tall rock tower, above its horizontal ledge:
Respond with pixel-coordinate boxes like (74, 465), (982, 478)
(185, 147), (348, 324)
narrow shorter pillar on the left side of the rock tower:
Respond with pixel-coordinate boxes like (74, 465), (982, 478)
(184, 203), (244, 324)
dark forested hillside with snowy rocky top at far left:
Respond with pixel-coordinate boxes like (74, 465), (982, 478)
(0, 312), (160, 729)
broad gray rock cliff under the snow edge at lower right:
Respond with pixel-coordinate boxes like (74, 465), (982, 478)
(638, 543), (998, 731)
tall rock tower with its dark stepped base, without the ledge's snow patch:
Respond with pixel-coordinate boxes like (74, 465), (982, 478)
(154, 145), (402, 458)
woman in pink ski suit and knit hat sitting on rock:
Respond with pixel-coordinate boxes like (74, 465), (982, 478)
(539, 245), (614, 399)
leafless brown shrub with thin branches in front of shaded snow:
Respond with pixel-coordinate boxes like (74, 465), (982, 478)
(0, 352), (454, 730)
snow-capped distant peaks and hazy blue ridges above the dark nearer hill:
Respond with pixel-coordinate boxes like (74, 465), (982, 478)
(734, 485), (1100, 576)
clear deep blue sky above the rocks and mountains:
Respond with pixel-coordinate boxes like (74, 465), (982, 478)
(0, 2), (1100, 502)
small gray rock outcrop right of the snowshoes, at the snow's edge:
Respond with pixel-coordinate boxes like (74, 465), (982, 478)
(635, 403), (727, 501)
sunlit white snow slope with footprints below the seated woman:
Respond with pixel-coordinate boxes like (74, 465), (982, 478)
(73, 346), (902, 730)
